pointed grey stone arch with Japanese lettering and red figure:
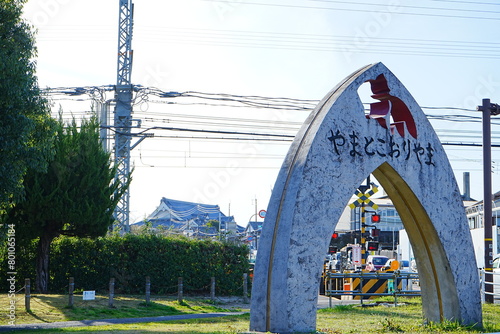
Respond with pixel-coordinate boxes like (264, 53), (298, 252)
(250, 63), (482, 333)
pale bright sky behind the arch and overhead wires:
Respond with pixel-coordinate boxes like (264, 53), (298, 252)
(20, 0), (500, 226)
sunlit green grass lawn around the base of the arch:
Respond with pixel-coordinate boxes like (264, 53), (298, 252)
(0, 295), (500, 334)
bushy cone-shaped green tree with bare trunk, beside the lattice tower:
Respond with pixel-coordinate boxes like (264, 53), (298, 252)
(8, 117), (128, 292)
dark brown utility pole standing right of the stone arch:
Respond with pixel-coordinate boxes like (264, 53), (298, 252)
(477, 99), (500, 303)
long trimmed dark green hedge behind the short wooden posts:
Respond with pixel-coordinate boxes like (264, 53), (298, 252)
(2, 235), (249, 295)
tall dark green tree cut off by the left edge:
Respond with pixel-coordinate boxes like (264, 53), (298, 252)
(0, 0), (54, 211)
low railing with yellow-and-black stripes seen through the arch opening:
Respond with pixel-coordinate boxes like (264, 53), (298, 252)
(324, 270), (420, 305)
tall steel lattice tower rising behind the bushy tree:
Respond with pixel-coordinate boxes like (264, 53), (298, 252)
(114, 0), (134, 232)
